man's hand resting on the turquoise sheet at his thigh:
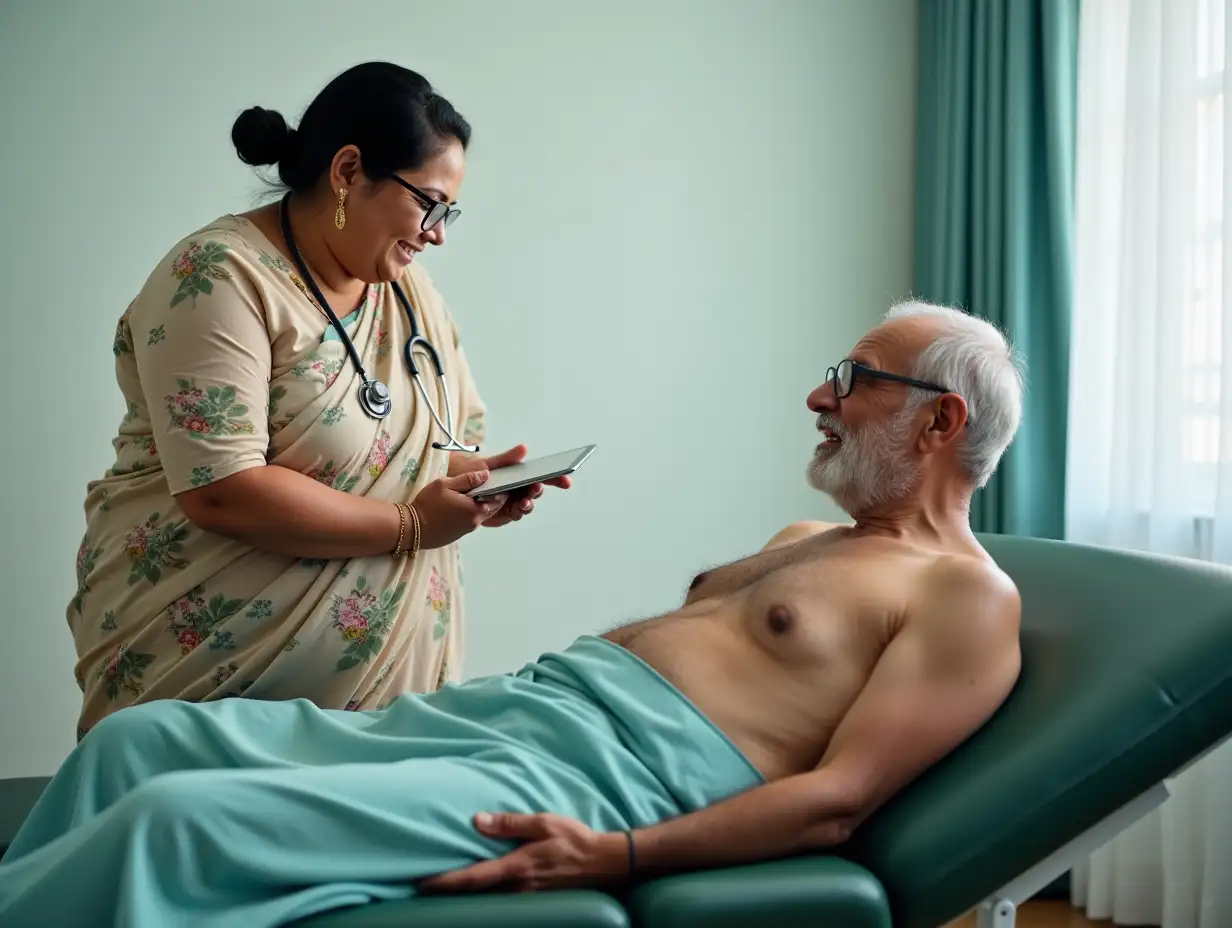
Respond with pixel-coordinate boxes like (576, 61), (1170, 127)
(418, 813), (628, 892)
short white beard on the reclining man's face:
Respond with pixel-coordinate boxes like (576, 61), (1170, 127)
(808, 408), (920, 518)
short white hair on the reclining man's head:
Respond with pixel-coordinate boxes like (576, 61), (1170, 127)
(886, 299), (1024, 488)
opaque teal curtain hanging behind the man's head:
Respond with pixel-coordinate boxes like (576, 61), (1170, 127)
(914, 0), (1078, 539)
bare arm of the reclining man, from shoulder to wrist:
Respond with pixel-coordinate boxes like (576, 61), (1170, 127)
(635, 560), (1020, 876)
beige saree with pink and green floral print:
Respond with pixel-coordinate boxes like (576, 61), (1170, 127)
(68, 216), (484, 737)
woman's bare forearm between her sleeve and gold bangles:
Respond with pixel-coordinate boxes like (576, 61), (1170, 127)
(176, 465), (413, 560)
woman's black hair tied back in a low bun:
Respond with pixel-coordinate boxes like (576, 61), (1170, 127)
(232, 62), (471, 193)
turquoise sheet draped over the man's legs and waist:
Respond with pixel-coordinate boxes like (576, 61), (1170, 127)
(0, 636), (763, 928)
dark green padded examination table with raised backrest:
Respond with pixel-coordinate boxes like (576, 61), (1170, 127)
(0, 536), (1232, 928)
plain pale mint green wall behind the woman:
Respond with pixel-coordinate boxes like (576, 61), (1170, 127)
(0, 0), (915, 776)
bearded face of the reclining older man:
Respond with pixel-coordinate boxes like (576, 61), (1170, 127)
(808, 323), (922, 516)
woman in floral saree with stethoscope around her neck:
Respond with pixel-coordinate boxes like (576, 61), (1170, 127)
(68, 63), (569, 737)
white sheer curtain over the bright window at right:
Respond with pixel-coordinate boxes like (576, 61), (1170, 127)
(1066, 0), (1232, 928)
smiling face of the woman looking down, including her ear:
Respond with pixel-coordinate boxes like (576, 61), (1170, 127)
(329, 139), (466, 283)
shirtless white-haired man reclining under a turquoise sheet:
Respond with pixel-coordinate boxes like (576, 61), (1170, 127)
(0, 303), (1021, 928)
